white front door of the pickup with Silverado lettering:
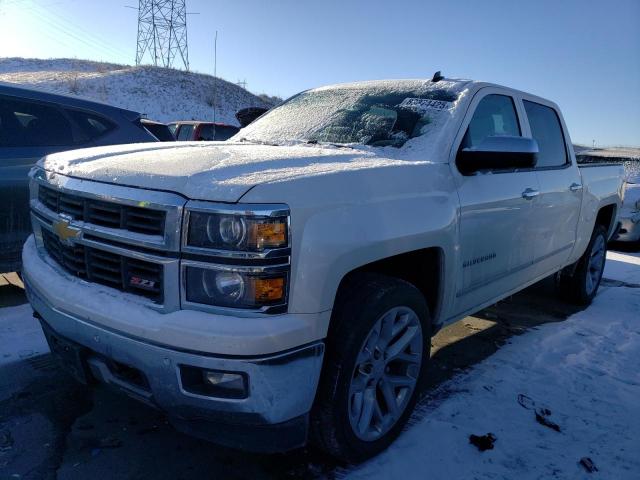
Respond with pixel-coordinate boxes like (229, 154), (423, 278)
(450, 87), (539, 314)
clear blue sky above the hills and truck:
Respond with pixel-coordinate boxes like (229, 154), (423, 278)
(0, 0), (640, 145)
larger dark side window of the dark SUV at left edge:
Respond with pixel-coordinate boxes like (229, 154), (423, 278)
(0, 96), (74, 147)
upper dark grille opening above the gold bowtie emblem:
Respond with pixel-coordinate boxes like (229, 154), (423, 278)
(38, 186), (166, 235)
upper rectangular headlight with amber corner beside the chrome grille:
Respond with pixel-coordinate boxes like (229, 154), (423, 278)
(185, 205), (289, 252)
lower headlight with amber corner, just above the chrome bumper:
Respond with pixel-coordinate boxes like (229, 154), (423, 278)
(185, 264), (288, 309)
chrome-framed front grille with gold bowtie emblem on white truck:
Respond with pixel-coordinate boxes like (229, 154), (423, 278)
(30, 169), (186, 312)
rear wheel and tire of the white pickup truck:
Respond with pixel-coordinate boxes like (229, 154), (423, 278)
(560, 225), (607, 305)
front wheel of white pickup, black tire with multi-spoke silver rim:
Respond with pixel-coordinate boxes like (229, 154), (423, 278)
(311, 274), (431, 463)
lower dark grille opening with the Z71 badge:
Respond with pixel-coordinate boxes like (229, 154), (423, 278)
(42, 230), (163, 303)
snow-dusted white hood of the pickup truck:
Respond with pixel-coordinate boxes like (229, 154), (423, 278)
(39, 142), (424, 202)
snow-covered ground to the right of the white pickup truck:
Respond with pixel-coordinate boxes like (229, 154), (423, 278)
(347, 252), (640, 480)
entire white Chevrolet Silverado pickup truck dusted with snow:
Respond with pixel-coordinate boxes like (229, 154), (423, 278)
(23, 75), (622, 461)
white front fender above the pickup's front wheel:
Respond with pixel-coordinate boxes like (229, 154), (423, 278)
(242, 162), (458, 338)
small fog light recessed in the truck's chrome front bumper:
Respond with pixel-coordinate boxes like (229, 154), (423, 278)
(180, 365), (249, 398)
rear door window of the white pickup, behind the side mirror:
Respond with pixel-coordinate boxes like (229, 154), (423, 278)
(523, 100), (567, 168)
